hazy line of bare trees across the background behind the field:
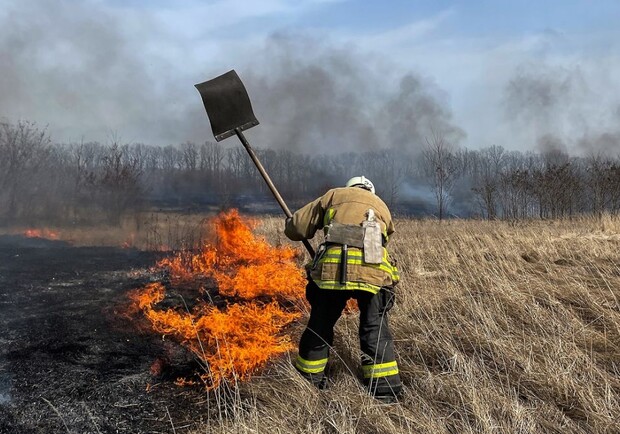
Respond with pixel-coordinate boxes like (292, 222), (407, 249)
(0, 122), (620, 224)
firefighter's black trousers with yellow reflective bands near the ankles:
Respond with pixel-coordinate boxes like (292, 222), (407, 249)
(295, 281), (402, 397)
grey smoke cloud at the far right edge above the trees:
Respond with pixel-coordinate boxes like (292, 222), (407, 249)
(503, 61), (620, 155)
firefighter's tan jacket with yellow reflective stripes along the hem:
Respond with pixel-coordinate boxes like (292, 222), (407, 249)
(284, 187), (399, 293)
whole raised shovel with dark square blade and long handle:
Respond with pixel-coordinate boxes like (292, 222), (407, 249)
(196, 69), (314, 256)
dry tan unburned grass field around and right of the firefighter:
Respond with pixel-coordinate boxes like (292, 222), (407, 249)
(189, 217), (620, 433)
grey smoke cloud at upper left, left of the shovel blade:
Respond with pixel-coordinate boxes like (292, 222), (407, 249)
(0, 0), (201, 143)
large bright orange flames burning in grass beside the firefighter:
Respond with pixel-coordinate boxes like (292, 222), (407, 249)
(129, 210), (305, 389)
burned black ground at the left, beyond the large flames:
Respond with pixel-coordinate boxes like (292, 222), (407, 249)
(0, 236), (216, 433)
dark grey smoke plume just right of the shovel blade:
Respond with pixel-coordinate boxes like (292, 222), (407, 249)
(240, 34), (463, 153)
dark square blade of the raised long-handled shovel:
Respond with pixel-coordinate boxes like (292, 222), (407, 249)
(195, 69), (258, 142)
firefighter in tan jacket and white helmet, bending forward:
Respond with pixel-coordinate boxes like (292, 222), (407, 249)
(284, 176), (402, 402)
